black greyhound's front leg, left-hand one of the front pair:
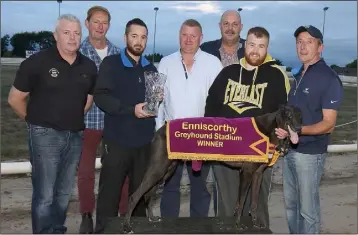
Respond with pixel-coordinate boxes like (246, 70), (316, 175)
(234, 166), (253, 230)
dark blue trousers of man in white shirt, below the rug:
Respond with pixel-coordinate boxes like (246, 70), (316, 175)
(160, 161), (211, 217)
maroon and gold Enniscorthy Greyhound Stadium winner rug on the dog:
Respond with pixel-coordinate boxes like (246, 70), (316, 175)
(166, 117), (278, 163)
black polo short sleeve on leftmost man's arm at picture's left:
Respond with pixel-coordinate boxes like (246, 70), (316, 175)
(13, 59), (35, 92)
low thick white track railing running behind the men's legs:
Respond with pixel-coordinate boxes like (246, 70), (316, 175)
(1, 144), (357, 175)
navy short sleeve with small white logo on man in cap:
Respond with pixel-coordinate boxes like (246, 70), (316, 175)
(322, 77), (343, 110)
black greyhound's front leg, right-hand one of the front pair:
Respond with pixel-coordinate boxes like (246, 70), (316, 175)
(250, 164), (267, 228)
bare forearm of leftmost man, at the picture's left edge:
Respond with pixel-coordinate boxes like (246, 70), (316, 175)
(8, 86), (30, 120)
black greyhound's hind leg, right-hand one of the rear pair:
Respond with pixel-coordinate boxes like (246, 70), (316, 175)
(144, 161), (178, 222)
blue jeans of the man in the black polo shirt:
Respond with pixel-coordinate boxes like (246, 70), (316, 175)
(28, 124), (83, 233)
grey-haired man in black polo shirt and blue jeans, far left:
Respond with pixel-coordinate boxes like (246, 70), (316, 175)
(8, 15), (97, 233)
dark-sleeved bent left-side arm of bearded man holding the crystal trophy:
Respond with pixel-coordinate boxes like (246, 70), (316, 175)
(93, 57), (135, 115)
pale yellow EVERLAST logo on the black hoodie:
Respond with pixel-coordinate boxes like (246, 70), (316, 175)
(224, 79), (267, 114)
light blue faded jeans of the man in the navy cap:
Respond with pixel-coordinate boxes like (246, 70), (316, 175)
(283, 150), (327, 234)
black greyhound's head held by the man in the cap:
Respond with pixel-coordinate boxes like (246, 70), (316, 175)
(276, 105), (302, 144)
